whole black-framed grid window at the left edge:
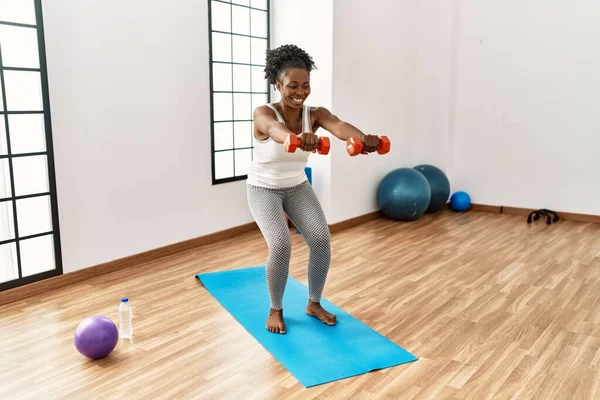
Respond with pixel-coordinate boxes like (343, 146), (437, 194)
(0, 0), (62, 291)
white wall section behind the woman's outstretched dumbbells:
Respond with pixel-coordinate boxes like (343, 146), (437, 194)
(330, 0), (417, 223)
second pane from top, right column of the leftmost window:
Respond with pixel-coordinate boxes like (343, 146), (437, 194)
(0, 25), (40, 68)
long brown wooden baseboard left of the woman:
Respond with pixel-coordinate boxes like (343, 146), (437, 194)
(0, 222), (258, 306)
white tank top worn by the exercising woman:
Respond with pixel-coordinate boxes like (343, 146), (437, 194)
(246, 104), (312, 189)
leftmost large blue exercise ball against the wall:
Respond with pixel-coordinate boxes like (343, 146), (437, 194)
(377, 168), (431, 221)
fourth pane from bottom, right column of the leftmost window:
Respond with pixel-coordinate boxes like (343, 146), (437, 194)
(8, 114), (46, 154)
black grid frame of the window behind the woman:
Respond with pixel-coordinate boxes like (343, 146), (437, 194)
(207, 0), (271, 186)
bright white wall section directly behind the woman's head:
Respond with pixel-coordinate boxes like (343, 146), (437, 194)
(271, 0), (335, 223)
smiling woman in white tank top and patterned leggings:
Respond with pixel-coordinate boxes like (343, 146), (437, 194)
(247, 45), (378, 333)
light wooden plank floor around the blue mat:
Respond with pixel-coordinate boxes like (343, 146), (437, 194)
(0, 212), (600, 399)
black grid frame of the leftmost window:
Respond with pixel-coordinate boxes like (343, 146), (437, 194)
(0, 0), (63, 293)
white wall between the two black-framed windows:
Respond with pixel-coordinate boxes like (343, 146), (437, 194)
(43, 0), (252, 272)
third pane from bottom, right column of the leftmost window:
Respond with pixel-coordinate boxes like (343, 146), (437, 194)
(13, 156), (49, 196)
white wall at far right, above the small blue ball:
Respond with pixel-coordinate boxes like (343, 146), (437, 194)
(422, 0), (600, 214)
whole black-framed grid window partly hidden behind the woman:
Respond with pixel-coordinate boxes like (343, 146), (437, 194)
(208, 0), (270, 184)
